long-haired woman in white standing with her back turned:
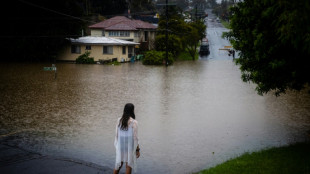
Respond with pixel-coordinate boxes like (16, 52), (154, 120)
(113, 103), (140, 174)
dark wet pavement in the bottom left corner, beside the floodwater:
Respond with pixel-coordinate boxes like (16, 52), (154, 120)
(0, 143), (112, 174)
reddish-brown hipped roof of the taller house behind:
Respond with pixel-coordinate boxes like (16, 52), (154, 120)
(89, 16), (157, 30)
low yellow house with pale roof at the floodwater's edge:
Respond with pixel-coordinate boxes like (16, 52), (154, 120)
(57, 36), (139, 62)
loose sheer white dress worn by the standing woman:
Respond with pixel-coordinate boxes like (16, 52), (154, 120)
(114, 117), (139, 172)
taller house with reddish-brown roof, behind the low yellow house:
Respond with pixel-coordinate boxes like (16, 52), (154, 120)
(89, 16), (157, 50)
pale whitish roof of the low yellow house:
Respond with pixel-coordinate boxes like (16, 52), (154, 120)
(69, 36), (139, 45)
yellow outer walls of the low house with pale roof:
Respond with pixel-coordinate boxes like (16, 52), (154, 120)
(57, 44), (134, 62)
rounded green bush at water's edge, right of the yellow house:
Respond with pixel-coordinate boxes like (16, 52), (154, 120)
(142, 50), (174, 65)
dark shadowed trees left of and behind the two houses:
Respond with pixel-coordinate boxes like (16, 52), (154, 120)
(0, 0), (152, 62)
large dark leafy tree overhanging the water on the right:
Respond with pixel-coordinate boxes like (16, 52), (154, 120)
(226, 0), (310, 95)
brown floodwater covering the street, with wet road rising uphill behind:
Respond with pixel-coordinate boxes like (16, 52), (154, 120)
(0, 9), (310, 174)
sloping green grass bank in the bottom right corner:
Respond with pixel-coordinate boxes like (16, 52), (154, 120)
(198, 143), (310, 174)
